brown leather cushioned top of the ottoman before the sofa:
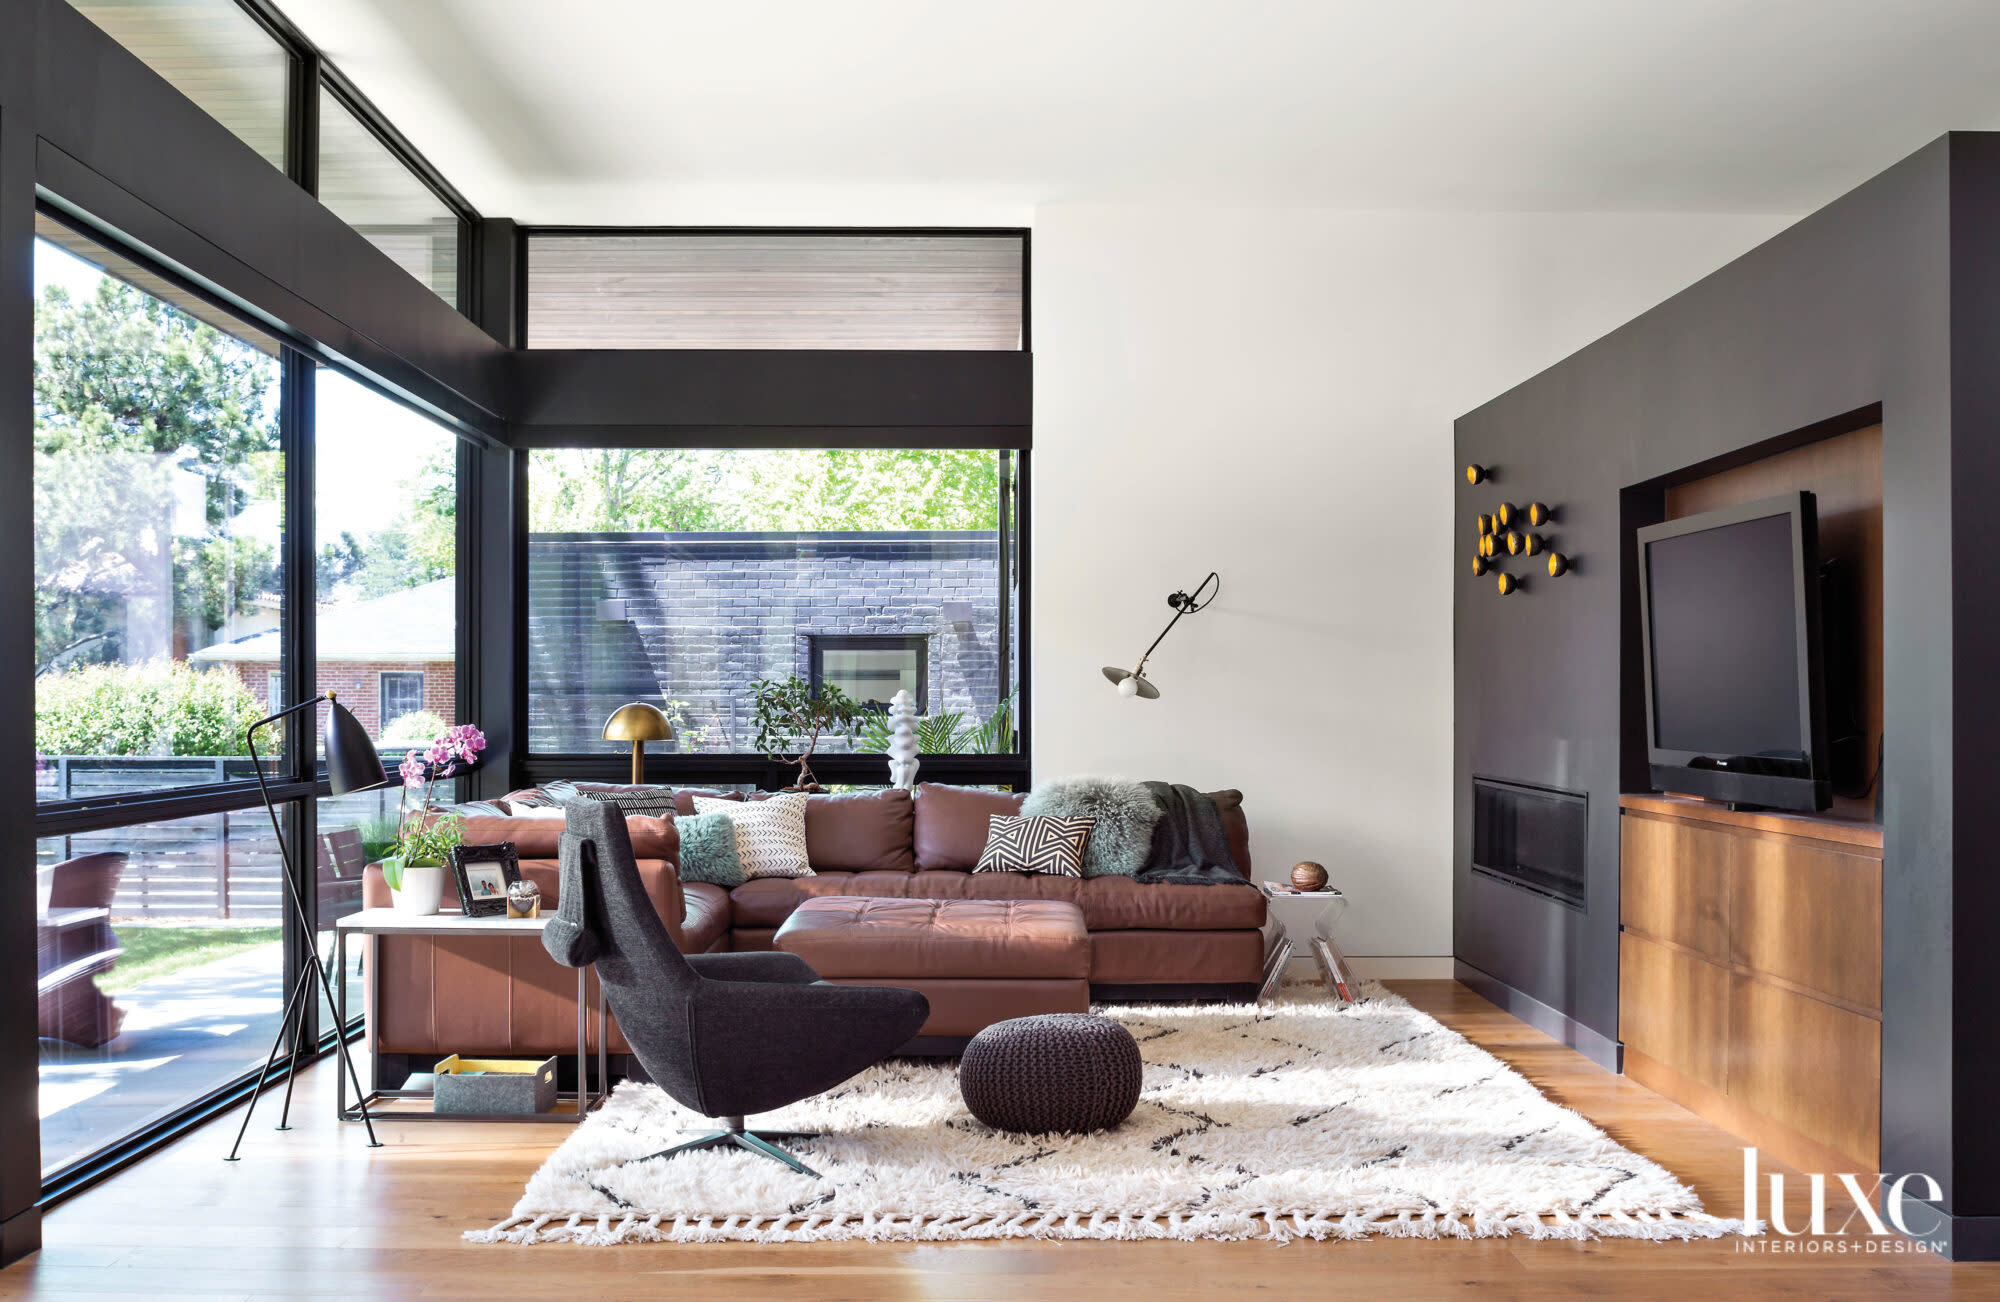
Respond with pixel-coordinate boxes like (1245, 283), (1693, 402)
(776, 896), (1090, 984)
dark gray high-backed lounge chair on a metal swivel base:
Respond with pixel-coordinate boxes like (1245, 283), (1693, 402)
(542, 800), (930, 1176)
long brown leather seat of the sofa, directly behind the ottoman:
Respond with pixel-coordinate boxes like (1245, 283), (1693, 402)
(788, 872), (1264, 932)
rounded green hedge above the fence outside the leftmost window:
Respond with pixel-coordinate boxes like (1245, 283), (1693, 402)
(34, 660), (276, 756)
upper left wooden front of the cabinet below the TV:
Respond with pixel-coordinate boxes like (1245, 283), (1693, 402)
(1618, 814), (1738, 960)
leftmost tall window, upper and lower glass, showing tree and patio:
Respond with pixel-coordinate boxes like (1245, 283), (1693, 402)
(34, 220), (292, 1170)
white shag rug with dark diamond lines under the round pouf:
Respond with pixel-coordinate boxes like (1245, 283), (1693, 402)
(466, 984), (1762, 1244)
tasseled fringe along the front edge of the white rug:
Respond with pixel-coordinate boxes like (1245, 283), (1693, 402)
(464, 1210), (1764, 1248)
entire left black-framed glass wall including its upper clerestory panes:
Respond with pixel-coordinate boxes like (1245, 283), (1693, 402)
(17, 0), (500, 1216)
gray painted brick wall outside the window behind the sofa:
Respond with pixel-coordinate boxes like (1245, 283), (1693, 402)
(528, 530), (1012, 754)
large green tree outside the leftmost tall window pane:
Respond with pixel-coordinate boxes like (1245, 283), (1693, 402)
(34, 276), (282, 672)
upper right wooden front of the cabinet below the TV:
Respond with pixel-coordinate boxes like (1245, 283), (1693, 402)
(1730, 836), (1882, 1010)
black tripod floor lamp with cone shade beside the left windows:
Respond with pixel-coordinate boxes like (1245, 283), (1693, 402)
(224, 692), (388, 1162)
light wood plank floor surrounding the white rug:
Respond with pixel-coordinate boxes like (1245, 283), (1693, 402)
(0, 980), (2000, 1302)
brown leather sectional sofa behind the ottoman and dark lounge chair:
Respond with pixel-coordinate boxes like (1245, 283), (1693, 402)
(362, 784), (1264, 1060)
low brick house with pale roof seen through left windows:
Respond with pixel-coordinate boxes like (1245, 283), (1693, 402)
(188, 578), (458, 738)
